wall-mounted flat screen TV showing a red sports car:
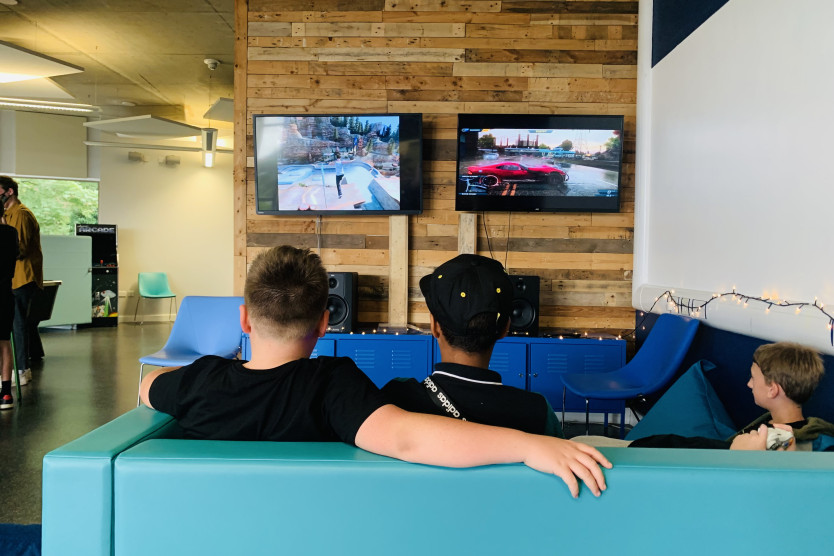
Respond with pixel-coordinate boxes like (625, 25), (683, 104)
(455, 114), (623, 212)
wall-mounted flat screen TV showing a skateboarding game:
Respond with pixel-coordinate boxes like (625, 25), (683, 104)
(252, 114), (423, 215)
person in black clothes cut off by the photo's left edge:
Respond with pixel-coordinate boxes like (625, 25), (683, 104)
(0, 204), (18, 409)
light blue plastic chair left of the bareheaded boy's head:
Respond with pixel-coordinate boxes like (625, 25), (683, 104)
(136, 296), (243, 406)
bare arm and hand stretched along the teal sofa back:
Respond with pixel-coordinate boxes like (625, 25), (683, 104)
(356, 404), (611, 498)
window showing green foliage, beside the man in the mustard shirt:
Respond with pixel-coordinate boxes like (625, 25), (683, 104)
(15, 178), (98, 232)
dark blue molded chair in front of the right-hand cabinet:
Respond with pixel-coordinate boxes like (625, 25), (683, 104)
(562, 313), (699, 437)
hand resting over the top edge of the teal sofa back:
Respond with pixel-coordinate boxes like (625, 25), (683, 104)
(524, 436), (611, 498)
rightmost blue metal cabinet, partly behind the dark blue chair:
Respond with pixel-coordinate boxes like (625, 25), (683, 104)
(529, 338), (625, 413)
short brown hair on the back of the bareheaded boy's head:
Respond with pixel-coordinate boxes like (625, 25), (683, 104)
(243, 245), (329, 339)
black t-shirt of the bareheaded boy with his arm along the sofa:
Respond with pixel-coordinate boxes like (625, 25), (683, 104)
(148, 355), (386, 445)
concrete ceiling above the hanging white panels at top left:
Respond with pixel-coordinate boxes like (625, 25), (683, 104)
(0, 0), (234, 128)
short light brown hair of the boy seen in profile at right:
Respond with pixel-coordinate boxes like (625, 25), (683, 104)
(753, 342), (825, 405)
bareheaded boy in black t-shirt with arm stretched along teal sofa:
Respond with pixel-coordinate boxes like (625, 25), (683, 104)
(141, 246), (611, 496)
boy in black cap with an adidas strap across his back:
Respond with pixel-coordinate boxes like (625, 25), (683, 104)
(382, 255), (562, 437)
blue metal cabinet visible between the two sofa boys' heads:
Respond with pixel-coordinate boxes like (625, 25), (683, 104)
(334, 334), (432, 387)
